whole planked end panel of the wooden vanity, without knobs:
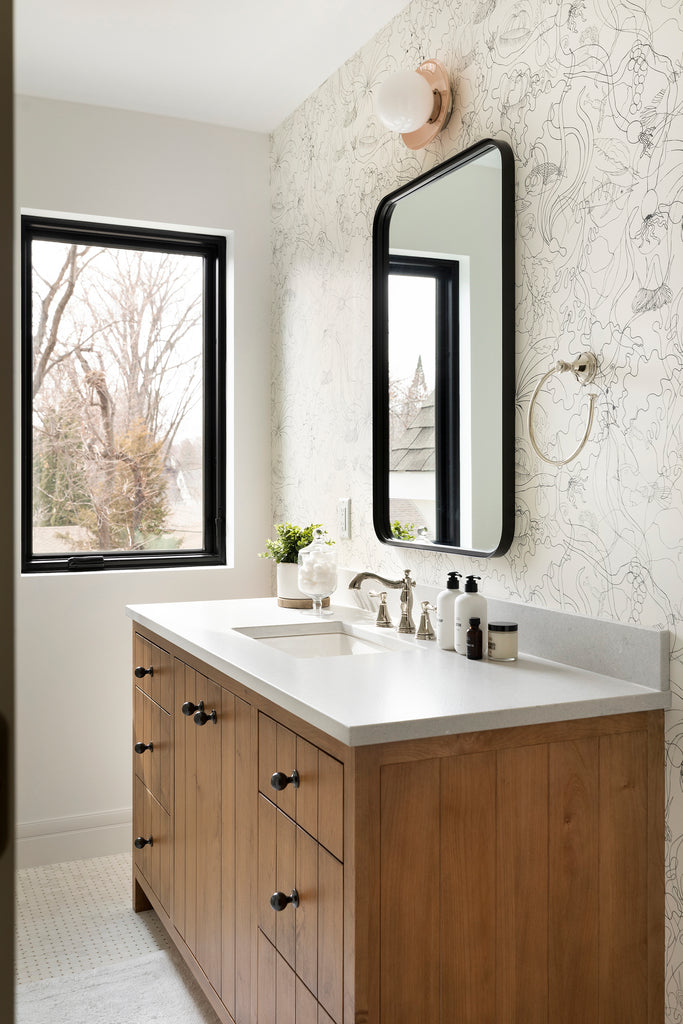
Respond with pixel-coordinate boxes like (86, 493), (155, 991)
(376, 726), (663, 1024)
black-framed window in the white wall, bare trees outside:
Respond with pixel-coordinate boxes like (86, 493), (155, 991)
(22, 216), (226, 572)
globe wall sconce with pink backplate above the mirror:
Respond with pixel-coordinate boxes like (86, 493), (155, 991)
(375, 59), (453, 150)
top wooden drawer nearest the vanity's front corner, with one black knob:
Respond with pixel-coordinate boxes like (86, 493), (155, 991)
(258, 714), (344, 860)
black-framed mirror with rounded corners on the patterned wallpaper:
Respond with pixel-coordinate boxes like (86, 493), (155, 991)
(373, 139), (515, 557)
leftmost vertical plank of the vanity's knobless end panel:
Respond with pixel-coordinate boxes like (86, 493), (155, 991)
(378, 760), (439, 1024)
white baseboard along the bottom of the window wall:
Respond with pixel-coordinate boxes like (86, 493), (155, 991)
(16, 807), (132, 868)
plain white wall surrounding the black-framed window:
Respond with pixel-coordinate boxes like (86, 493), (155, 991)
(15, 97), (271, 864)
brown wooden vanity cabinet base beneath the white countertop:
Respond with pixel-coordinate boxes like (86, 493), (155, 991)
(134, 628), (664, 1024)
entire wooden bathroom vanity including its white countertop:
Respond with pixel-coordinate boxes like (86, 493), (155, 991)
(128, 600), (669, 1024)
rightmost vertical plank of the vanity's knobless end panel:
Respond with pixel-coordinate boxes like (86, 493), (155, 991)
(599, 732), (648, 1024)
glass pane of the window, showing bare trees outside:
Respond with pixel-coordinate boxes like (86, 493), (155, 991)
(31, 240), (205, 555)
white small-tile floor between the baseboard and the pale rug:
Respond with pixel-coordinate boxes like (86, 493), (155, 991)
(15, 854), (170, 985)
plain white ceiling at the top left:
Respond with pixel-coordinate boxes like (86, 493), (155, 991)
(14, 0), (407, 132)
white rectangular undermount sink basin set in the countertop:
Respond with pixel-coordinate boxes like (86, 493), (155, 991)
(234, 622), (411, 657)
